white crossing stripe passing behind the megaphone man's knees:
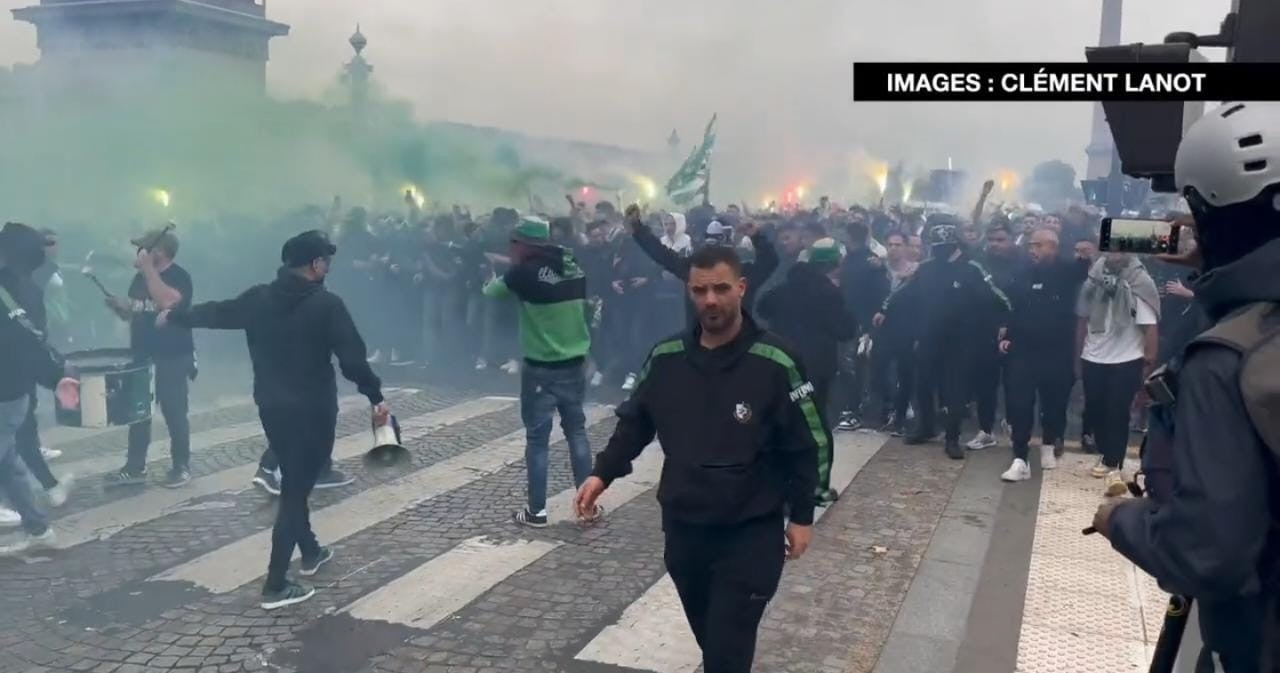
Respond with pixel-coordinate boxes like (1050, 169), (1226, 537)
(52, 398), (512, 548)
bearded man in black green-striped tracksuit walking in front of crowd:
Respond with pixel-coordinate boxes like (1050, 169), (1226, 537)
(575, 247), (814, 673)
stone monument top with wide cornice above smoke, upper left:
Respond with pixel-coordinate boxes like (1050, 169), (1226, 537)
(13, 0), (289, 90)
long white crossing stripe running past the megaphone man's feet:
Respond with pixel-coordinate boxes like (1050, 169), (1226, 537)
(152, 406), (613, 594)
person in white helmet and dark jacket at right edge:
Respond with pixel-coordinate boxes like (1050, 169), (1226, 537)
(1093, 102), (1280, 673)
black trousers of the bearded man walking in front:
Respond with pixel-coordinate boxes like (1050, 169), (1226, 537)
(663, 514), (786, 673)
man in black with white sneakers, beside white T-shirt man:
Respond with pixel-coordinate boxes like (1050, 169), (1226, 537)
(1000, 229), (1089, 481)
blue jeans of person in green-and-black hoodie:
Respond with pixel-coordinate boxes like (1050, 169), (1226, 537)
(520, 362), (591, 514)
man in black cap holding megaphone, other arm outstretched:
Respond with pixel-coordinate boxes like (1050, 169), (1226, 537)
(159, 232), (389, 609)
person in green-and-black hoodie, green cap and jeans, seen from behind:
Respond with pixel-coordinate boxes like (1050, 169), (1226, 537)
(484, 216), (600, 528)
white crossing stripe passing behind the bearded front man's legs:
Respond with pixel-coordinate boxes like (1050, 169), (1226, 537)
(576, 432), (888, 673)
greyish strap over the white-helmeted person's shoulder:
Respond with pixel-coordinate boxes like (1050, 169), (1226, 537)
(1190, 302), (1280, 454)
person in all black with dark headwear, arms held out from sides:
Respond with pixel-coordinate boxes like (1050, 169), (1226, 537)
(873, 215), (1009, 461)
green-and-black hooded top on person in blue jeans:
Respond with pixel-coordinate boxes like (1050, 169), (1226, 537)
(484, 246), (591, 367)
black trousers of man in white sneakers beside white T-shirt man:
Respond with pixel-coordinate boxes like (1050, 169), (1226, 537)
(1005, 344), (1075, 461)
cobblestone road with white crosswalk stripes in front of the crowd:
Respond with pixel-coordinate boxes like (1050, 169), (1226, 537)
(0, 371), (1003, 673)
